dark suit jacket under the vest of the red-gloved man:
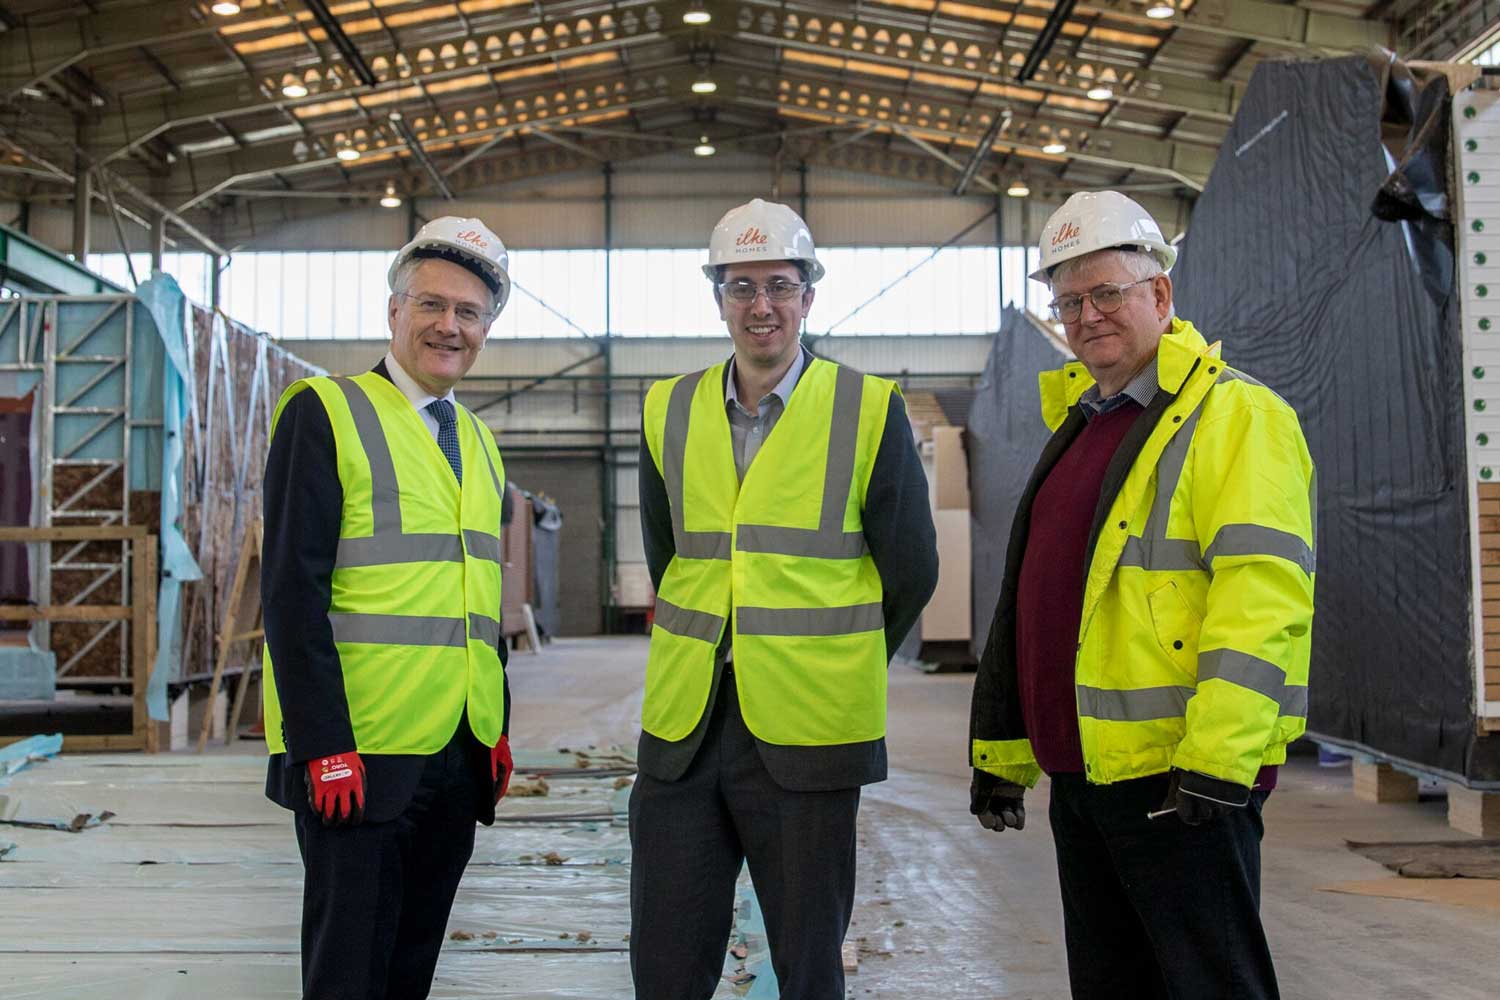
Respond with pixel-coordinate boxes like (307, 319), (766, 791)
(261, 360), (510, 825)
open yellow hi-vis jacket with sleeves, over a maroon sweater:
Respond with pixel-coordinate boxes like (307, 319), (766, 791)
(971, 319), (1316, 787)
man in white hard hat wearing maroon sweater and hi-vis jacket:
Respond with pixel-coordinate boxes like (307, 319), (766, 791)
(969, 190), (1314, 1000)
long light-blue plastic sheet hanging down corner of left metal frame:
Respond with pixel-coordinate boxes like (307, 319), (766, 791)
(135, 271), (203, 721)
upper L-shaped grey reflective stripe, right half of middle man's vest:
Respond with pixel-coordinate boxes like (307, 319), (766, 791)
(735, 364), (869, 559)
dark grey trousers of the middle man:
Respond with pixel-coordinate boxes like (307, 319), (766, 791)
(630, 669), (860, 1000)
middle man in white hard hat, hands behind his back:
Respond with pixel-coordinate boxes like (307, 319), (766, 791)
(630, 198), (938, 1000)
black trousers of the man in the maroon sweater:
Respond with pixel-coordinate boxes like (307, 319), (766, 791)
(1050, 774), (1280, 1000)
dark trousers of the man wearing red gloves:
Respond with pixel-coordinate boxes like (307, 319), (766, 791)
(296, 727), (477, 1000)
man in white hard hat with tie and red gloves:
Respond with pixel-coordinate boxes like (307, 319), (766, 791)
(261, 217), (512, 1000)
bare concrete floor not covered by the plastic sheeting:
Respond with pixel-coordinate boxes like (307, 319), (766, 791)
(512, 639), (1500, 1000)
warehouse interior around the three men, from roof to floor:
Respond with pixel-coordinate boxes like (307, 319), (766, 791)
(0, 0), (1500, 1000)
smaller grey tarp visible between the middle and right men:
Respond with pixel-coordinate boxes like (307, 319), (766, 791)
(965, 307), (1065, 658)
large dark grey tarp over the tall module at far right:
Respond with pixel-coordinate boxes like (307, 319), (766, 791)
(1173, 57), (1500, 781)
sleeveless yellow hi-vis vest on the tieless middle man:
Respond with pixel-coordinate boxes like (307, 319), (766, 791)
(641, 358), (897, 747)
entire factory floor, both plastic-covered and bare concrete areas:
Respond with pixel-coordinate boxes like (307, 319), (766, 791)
(0, 637), (1500, 1000)
